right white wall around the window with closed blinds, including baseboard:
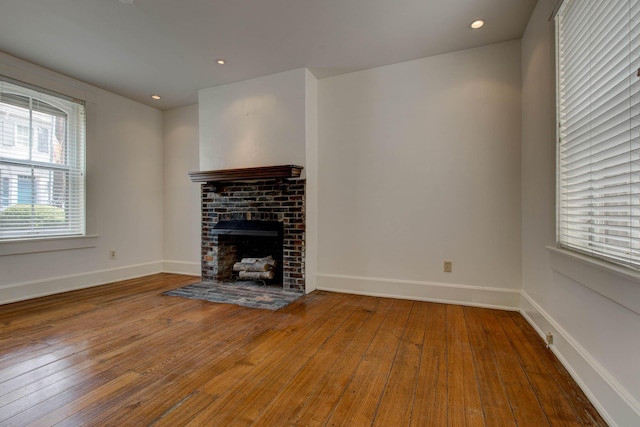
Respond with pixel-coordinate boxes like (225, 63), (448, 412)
(522, 1), (640, 426)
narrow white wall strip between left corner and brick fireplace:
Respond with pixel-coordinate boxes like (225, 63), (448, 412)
(163, 104), (201, 276)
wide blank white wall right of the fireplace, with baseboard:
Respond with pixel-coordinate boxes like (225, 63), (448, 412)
(318, 41), (521, 309)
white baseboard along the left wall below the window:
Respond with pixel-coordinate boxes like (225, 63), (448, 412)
(0, 261), (163, 304)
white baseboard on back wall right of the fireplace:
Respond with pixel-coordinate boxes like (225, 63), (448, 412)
(316, 274), (520, 311)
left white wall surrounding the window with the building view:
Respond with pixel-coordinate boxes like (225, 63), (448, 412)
(0, 53), (163, 303)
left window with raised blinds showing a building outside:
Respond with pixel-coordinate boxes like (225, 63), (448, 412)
(0, 77), (85, 240)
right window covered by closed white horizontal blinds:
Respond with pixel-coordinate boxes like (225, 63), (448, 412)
(556, 0), (640, 269)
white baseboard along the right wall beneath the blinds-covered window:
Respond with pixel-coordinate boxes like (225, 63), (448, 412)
(520, 291), (640, 426)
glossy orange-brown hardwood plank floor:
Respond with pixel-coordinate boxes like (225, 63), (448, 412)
(0, 274), (606, 426)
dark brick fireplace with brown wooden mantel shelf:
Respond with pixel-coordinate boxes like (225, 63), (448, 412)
(190, 166), (306, 291)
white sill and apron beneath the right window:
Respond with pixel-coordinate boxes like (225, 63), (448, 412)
(547, 246), (640, 314)
